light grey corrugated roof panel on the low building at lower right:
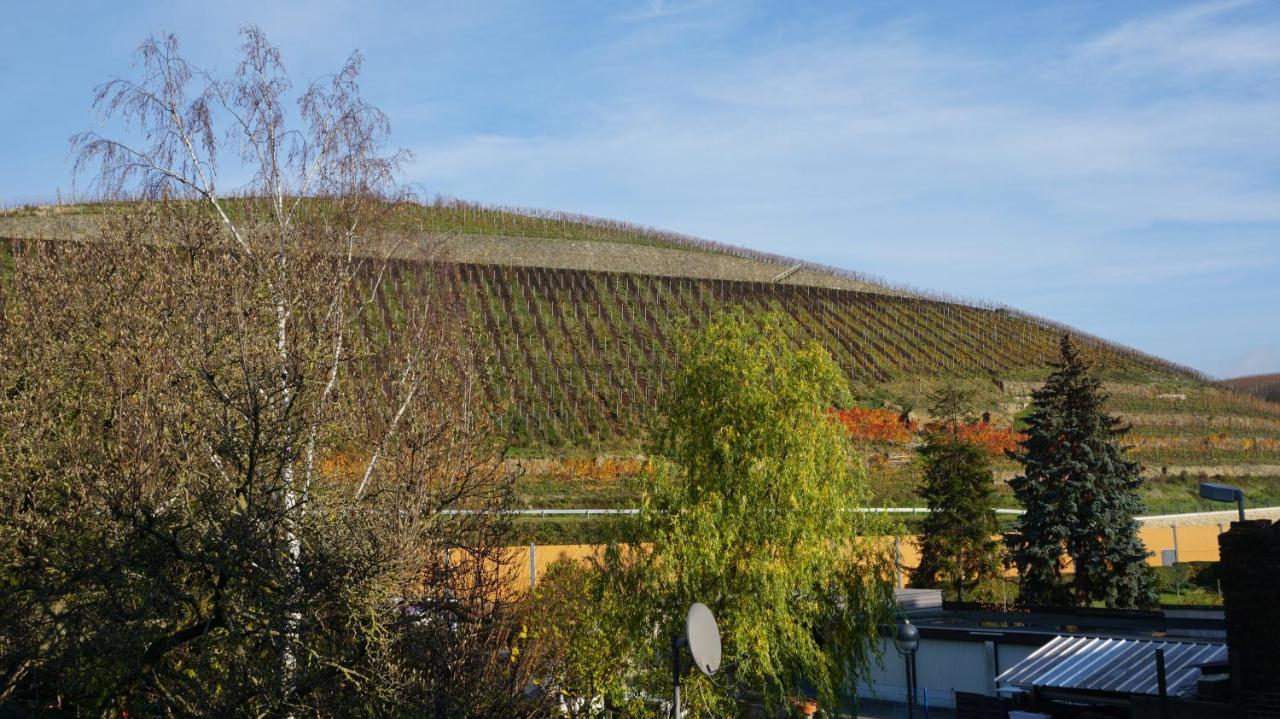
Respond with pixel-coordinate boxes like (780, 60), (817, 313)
(996, 636), (1226, 696)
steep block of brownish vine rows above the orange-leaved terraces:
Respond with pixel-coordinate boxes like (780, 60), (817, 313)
(353, 262), (1228, 446)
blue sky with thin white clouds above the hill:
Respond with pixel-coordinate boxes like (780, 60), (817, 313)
(0, 0), (1280, 376)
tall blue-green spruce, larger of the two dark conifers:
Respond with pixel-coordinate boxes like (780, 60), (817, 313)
(1005, 335), (1157, 608)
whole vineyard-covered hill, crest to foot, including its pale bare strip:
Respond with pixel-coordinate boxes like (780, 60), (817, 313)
(0, 198), (1280, 524)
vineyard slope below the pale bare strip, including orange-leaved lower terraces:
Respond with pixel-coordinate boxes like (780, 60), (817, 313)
(360, 257), (1280, 510)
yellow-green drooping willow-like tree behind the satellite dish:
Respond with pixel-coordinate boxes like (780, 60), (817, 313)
(552, 313), (892, 716)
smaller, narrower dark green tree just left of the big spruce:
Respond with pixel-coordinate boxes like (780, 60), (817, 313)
(911, 383), (1000, 600)
